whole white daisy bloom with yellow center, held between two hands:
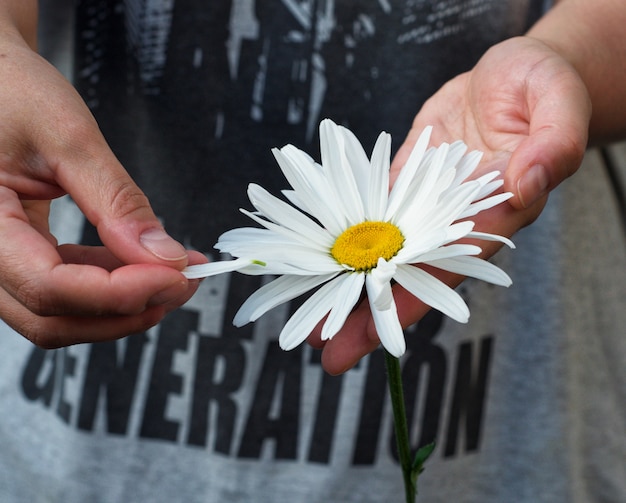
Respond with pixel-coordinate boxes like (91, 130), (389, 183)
(184, 120), (513, 357)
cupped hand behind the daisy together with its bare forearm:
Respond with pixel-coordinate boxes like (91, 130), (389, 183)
(309, 0), (626, 374)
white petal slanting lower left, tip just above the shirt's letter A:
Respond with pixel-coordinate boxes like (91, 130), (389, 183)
(278, 276), (343, 351)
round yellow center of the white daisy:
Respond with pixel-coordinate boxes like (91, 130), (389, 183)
(330, 222), (404, 271)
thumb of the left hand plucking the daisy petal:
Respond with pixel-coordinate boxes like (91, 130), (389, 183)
(25, 83), (187, 270)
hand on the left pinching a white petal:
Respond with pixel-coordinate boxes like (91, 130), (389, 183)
(0, 31), (205, 348)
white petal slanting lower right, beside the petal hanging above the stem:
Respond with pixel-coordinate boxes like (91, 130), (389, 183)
(394, 265), (469, 323)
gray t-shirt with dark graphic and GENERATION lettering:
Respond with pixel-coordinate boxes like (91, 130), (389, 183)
(0, 0), (626, 503)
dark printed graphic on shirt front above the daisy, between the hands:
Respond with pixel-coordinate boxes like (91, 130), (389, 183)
(70, 0), (539, 251)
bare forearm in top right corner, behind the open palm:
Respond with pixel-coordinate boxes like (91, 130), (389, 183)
(528, 0), (626, 143)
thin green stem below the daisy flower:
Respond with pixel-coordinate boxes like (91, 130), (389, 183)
(385, 350), (417, 503)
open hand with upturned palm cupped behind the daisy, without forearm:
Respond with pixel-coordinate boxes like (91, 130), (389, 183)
(309, 37), (591, 374)
